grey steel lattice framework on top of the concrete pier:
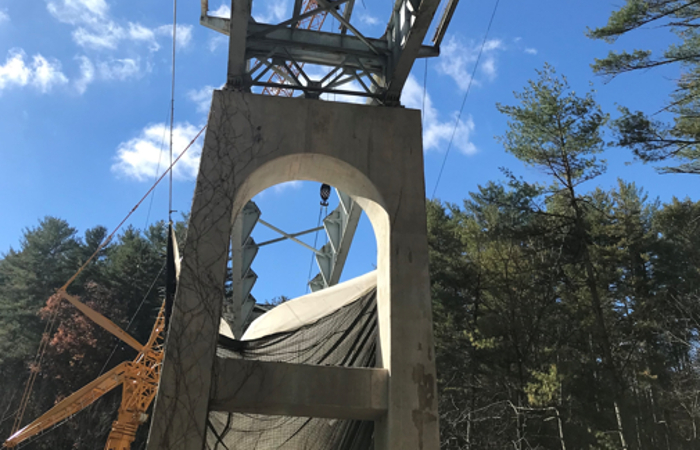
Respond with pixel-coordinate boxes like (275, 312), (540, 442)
(200, 0), (457, 105)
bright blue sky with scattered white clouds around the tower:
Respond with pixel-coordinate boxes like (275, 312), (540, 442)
(0, 0), (698, 300)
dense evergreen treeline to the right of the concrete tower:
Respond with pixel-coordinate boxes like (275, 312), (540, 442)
(428, 67), (700, 450)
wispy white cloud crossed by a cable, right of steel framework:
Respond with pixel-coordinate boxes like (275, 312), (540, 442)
(437, 37), (504, 91)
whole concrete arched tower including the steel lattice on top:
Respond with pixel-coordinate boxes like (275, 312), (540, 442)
(148, 0), (456, 450)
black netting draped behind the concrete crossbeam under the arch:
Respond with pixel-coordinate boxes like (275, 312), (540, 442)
(206, 288), (377, 450)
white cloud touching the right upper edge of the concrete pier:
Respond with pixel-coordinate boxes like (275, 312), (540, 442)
(401, 76), (476, 155)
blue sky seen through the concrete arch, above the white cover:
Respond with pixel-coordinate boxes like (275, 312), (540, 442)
(250, 181), (377, 304)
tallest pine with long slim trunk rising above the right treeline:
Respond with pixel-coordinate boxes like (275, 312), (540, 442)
(497, 65), (644, 448)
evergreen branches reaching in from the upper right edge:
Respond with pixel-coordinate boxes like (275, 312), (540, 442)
(588, 0), (700, 174)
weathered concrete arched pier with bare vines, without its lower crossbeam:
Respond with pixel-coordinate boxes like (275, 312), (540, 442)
(148, 91), (439, 450)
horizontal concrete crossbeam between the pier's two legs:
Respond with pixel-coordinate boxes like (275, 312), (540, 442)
(209, 358), (389, 420)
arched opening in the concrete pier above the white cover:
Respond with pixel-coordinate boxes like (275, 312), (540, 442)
(224, 154), (389, 334)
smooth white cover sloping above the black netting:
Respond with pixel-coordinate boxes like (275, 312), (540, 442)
(241, 270), (377, 341)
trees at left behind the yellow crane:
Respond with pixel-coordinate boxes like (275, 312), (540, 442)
(0, 217), (184, 450)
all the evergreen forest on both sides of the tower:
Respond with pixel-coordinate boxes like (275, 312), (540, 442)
(0, 0), (700, 450)
